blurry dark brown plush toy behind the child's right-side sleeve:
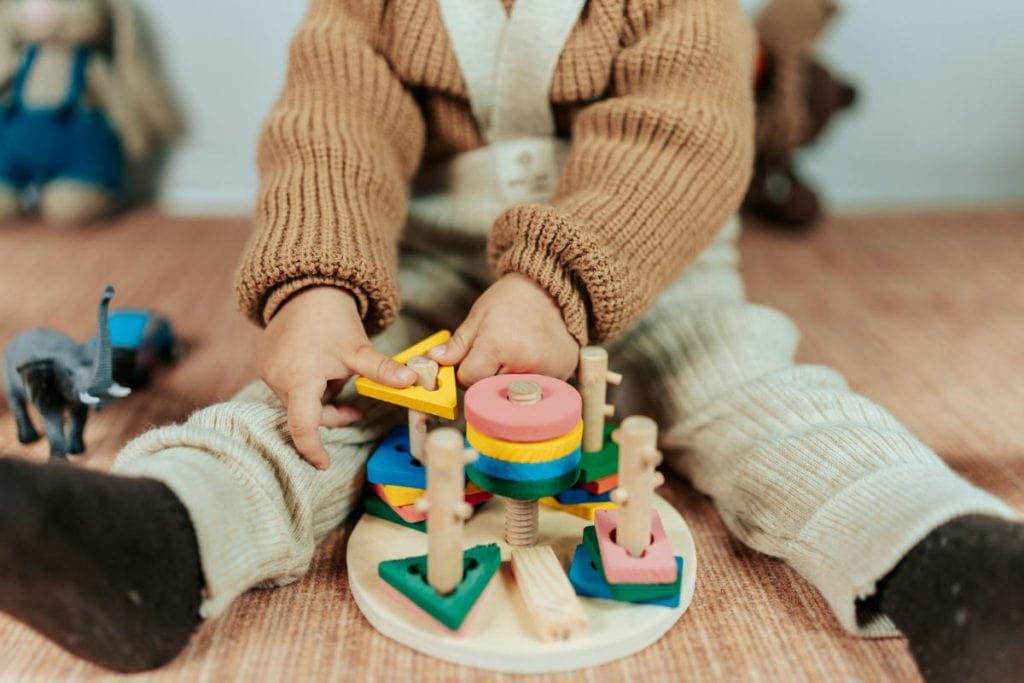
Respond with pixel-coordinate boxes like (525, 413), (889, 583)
(744, 0), (856, 230)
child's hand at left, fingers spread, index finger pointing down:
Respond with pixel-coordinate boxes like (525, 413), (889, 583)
(257, 287), (417, 470)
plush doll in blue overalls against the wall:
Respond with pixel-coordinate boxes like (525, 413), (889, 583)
(0, 0), (178, 223)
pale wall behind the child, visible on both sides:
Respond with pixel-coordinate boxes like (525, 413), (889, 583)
(146, 0), (1024, 213)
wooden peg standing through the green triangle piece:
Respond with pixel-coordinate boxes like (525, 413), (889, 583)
(426, 427), (472, 595)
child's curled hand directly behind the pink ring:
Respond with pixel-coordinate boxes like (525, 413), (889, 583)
(428, 273), (580, 386)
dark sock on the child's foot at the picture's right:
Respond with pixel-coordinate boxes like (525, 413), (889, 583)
(879, 515), (1024, 683)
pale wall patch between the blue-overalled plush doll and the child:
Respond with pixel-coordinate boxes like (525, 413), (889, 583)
(136, 0), (306, 213)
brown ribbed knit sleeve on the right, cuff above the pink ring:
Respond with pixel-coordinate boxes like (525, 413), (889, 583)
(489, 0), (755, 343)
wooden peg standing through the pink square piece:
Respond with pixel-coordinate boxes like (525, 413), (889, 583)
(612, 417), (660, 557)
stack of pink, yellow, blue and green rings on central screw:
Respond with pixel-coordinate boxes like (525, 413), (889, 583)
(465, 375), (583, 500)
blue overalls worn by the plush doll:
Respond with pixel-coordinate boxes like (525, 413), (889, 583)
(0, 45), (123, 191)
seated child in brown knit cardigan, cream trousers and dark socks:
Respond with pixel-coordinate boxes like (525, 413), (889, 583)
(0, 0), (1024, 680)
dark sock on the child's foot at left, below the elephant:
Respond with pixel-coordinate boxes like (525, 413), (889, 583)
(0, 459), (203, 672)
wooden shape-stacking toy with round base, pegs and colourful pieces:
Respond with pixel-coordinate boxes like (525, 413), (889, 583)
(347, 333), (696, 673)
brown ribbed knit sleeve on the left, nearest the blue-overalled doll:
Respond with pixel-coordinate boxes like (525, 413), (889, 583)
(237, 0), (425, 333)
